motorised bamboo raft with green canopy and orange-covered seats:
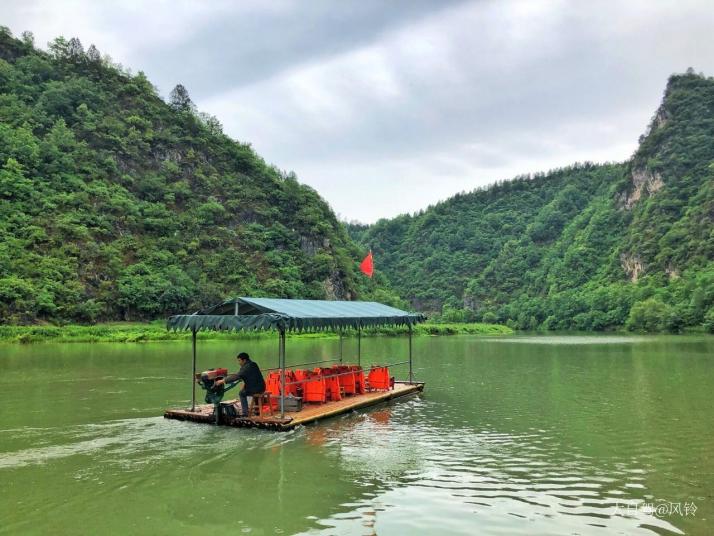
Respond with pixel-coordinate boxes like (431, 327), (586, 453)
(164, 297), (426, 431)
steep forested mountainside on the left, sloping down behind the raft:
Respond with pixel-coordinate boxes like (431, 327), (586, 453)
(0, 28), (392, 322)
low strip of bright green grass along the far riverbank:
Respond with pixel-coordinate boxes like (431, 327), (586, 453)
(0, 320), (514, 344)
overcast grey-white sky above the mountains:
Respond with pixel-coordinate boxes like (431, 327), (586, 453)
(0, 0), (714, 222)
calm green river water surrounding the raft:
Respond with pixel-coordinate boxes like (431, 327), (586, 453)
(0, 335), (714, 535)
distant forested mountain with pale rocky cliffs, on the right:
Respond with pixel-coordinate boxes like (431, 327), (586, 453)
(349, 70), (714, 331)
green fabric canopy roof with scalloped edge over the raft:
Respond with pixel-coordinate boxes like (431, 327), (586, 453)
(167, 298), (426, 331)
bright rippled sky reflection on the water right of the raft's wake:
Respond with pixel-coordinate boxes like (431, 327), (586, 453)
(296, 401), (683, 534)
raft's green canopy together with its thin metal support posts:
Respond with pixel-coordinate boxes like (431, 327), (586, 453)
(173, 298), (426, 419)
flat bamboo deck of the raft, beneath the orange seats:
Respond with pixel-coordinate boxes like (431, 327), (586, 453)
(164, 381), (424, 431)
